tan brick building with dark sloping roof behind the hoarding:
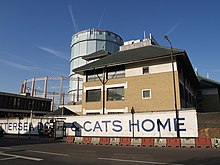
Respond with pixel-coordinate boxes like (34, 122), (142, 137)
(73, 40), (199, 115)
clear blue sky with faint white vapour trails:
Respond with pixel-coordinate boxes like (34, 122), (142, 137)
(0, 0), (220, 93)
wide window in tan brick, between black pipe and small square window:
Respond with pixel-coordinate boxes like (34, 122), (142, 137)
(107, 87), (124, 101)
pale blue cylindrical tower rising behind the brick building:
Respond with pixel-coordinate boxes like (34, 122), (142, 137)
(69, 29), (123, 102)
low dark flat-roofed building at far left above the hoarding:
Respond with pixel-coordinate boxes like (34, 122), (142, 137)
(0, 92), (51, 118)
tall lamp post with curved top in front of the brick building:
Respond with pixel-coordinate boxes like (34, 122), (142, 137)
(164, 35), (180, 138)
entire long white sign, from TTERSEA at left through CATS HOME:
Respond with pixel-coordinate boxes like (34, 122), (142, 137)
(0, 110), (198, 137)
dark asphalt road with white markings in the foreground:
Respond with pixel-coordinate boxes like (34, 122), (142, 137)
(0, 138), (220, 165)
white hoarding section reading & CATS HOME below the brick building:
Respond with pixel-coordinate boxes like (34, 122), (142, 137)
(65, 110), (198, 137)
